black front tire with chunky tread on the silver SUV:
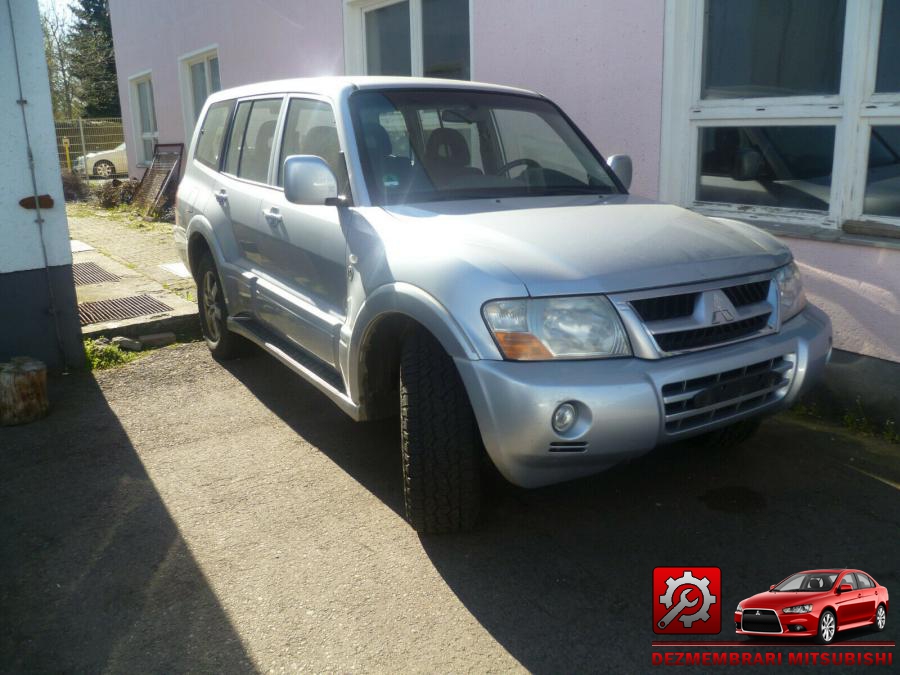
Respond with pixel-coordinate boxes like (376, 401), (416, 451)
(400, 331), (484, 534)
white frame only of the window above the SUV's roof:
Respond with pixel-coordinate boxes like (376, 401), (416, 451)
(344, 0), (475, 80)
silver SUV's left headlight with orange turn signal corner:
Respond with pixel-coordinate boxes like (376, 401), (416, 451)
(482, 295), (631, 361)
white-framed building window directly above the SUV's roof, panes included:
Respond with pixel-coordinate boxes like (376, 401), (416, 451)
(344, 0), (471, 80)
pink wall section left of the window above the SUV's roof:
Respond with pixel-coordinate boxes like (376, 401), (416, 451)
(109, 0), (344, 176)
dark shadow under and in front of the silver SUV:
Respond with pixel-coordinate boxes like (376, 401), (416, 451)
(223, 354), (900, 672)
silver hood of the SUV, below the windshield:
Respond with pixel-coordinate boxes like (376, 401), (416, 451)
(385, 195), (791, 296)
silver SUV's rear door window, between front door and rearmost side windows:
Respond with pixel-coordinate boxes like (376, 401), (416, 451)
(225, 98), (281, 183)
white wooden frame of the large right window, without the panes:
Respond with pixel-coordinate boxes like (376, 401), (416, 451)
(659, 0), (900, 236)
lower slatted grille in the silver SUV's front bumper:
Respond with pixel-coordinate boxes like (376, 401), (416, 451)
(662, 356), (794, 434)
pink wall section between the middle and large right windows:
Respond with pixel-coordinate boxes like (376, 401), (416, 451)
(472, 0), (665, 197)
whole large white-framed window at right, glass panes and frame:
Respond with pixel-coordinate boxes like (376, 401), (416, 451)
(660, 0), (900, 234)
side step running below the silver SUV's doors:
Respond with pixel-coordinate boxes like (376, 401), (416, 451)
(228, 316), (360, 420)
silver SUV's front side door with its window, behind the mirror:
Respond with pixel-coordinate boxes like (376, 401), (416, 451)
(258, 96), (347, 365)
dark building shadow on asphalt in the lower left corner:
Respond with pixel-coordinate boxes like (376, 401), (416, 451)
(0, 373), (254, 672)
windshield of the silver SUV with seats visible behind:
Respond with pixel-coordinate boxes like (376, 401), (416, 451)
(350, 89), (619, 204)
